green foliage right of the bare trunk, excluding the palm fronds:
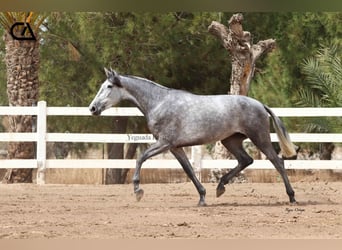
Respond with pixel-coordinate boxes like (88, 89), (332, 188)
(244, 12), (342, 106)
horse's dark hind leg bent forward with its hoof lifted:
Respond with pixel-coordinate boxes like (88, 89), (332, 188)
(216, 134), (253, 197)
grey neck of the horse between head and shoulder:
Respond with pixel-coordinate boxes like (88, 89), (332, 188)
(121, 76), (168, 116)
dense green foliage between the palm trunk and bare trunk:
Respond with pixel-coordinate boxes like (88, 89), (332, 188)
(36, 12), (230, 139)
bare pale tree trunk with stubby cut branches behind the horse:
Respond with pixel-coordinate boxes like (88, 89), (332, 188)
(208, 13), (275, 181)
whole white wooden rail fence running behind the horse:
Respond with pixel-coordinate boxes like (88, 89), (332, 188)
(0, 101), (342, 184)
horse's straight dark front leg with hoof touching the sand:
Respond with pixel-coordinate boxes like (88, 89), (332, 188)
(170, 148), (206, 206)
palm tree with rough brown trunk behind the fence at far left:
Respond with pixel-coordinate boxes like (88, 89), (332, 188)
(0, 12), (46, 183)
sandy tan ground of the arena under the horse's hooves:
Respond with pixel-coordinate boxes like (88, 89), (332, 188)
(0, 182), (342, 239)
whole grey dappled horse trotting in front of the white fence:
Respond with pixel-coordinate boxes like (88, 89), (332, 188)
(89, 68), (296, 206)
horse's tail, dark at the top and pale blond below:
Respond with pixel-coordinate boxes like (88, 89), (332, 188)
(264, 105), (299, 158)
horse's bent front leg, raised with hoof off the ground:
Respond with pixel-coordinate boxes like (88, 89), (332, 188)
(133, 141), (170, 201)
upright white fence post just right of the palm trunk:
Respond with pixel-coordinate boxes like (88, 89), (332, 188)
(37, 101), (46, 185)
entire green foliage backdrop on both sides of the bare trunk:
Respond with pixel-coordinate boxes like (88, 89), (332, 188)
(0, 12), (342, 145)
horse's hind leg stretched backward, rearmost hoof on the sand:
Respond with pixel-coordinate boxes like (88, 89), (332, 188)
(250, 133), (296, 203)
